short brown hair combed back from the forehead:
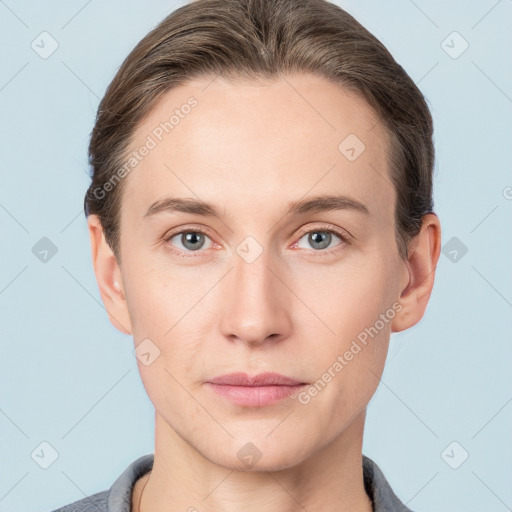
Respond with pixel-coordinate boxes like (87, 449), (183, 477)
(84, 0), (434, 261)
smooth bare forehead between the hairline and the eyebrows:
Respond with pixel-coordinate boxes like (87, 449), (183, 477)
(122, 74), (394, 222)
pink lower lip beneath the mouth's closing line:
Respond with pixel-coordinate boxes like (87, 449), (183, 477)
(208, 382), (306, 407)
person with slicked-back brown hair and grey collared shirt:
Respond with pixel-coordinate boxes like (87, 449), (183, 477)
(54, 0), (441, 512)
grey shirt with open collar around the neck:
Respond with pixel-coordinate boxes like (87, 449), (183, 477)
(53, 453), (412, 512)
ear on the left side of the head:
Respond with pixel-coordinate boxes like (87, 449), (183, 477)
(87, 215), (132, 334)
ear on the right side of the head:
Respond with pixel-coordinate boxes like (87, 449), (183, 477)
(391, 213), (441, 332)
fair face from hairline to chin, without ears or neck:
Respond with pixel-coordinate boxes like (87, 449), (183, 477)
(110, 74), (405, 469)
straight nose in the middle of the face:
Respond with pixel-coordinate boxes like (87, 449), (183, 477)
(221, 242), (293, 346)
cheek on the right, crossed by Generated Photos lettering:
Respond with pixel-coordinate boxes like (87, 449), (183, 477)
(286, 250), (396, 410)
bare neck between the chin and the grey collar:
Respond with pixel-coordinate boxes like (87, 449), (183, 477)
(132, 411), (372, 512)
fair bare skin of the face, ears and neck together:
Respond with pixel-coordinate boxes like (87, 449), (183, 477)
(88, 74), (441, 512)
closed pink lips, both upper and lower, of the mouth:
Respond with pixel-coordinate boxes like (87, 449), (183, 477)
(206, 372), (306, 407)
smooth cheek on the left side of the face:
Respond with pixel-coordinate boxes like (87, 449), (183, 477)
(126, 265), (205, 417)
